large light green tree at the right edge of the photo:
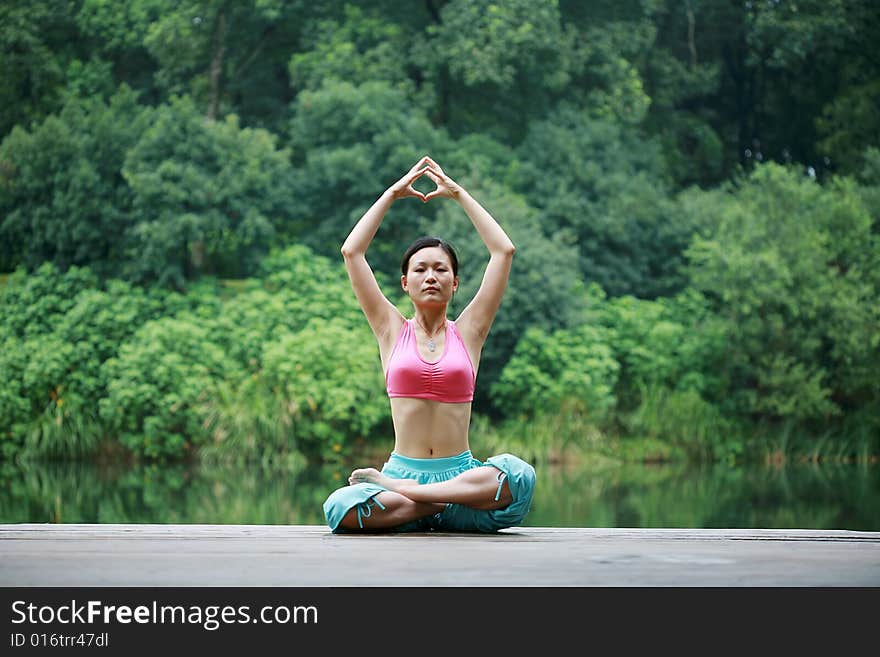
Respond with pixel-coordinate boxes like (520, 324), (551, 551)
(688, 164), (880, 423)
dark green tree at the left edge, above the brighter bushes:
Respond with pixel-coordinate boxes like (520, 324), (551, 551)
(0, 87), (151, 275)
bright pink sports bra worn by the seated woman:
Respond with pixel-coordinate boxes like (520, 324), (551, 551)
(385, 319), (476, 403)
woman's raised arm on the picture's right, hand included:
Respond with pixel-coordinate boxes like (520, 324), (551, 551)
(425, 157), (516, 346)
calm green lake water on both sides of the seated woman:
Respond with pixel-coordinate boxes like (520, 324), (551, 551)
(0, 462), (880, 531)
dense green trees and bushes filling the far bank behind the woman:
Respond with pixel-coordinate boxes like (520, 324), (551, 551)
(0, 0), (880, 459)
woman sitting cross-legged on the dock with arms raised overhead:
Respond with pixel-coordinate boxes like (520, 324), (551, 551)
(324, 155), (535, 532)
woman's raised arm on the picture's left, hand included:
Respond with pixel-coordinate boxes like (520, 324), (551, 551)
(342, 157), (427, 346)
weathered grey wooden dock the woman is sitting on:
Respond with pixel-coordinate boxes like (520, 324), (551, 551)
(0, 524), (880, 587)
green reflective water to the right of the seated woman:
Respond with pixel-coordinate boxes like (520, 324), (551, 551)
(529, 464), (880, 531)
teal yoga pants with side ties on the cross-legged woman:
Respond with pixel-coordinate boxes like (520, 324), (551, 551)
(324, 450), (535, 533)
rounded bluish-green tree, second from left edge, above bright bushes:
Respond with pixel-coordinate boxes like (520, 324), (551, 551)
(122, 98), (293, 286)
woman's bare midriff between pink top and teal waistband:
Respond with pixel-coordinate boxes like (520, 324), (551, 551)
(391, 397), (471, 459)
